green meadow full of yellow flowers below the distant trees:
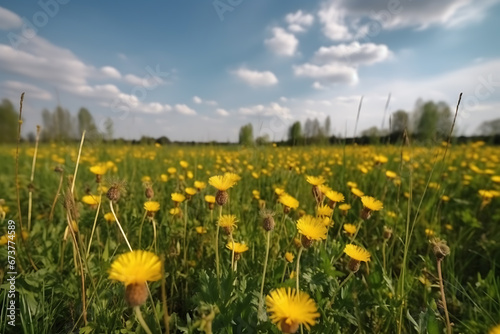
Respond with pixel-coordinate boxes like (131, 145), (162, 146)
(0, 142), (500, 334)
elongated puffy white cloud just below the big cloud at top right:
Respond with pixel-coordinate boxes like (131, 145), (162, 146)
(313, 42), (391, 66)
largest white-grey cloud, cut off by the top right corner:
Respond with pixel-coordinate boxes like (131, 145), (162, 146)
(318, 0), (499, 41)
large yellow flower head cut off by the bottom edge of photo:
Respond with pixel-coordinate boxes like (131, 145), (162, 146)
(266, 288), (319, 333)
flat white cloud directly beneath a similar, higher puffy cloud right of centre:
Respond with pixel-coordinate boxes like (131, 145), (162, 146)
(293, 63), (358, 84)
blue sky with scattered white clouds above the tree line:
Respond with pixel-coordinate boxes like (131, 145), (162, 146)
(0, 0), (500, 141)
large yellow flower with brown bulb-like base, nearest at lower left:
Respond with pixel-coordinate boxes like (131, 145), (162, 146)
(109, 250), (162, 307)
